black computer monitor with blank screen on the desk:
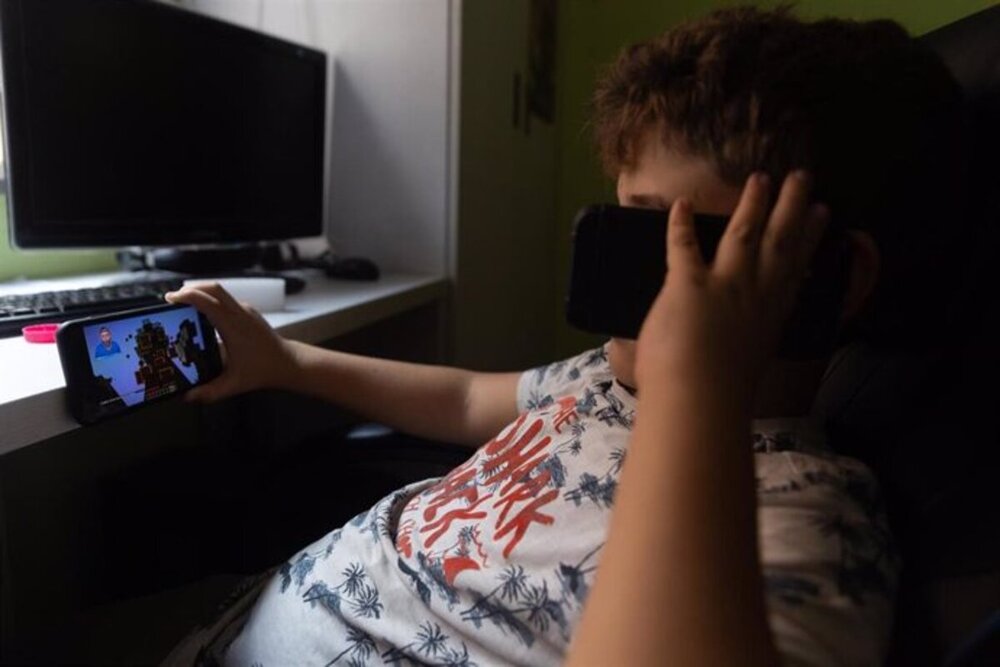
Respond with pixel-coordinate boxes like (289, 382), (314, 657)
(0, 0), (326, 247)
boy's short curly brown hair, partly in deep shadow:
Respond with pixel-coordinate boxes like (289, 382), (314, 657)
(593, 6), (962, 350)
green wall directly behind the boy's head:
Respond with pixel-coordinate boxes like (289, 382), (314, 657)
(555, 0), (995, 356)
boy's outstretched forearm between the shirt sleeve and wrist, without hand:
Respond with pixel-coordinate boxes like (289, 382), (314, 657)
(277, 342), (517, 446)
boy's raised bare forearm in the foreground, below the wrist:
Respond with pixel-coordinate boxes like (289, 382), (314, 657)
(570, 378), (775, 666)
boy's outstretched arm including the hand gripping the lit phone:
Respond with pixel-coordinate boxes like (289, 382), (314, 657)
(167, 285), (520, 446)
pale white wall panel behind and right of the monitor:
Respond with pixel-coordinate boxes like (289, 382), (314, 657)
(184, 0), (450, 274)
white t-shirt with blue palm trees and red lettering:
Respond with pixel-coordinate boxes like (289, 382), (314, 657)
(174, 348), (897, 667)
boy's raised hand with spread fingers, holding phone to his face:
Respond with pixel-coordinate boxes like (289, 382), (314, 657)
(636, 172), (829, 401)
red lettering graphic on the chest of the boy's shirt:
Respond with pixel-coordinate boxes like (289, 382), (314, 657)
(406, 397), (579, 583)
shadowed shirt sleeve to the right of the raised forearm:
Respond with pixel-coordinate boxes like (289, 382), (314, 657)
(756, 452), (899, 666)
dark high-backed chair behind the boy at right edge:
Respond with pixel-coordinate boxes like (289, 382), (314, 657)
(814, 6), (1000, 667)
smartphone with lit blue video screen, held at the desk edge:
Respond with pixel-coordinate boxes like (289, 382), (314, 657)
(56, 304), (222, 424)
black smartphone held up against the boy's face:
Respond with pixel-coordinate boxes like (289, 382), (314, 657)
(566, 204), (848, 359)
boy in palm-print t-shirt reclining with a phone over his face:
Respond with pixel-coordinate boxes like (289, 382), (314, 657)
(169, 9), (957, 665)
